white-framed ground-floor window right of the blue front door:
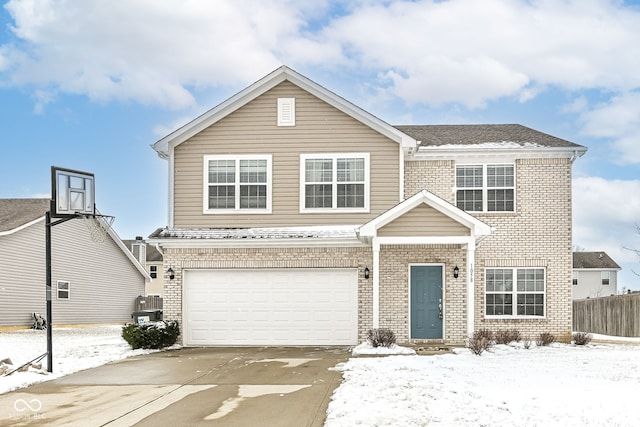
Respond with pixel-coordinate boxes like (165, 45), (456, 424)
(485, 268), (546, 317)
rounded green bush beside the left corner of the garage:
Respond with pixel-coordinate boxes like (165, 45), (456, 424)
(122, 320), (180, 350)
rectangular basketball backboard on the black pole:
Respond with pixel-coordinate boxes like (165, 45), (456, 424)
(51, 166), (95, 218)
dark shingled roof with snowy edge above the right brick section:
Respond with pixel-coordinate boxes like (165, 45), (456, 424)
(396, 124), (585, 150)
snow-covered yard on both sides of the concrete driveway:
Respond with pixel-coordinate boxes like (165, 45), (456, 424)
(0, 326), (640, 427)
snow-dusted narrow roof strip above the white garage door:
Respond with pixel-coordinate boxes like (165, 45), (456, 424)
(151, 225), (359, 240)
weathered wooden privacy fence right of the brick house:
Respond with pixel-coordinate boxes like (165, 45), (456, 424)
(573, 293), (640, 337)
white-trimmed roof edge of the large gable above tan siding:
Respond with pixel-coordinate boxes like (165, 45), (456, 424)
(152, 65), (417, 159)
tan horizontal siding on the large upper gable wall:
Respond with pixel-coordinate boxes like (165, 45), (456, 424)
(174, 82), (400, 227)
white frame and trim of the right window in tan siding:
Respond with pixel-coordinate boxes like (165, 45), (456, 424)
(299, 153), (371, 214)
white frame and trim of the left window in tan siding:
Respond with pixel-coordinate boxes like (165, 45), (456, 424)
(202, 154), (273, 215)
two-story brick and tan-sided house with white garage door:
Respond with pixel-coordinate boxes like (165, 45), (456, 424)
(148, 67), (586, 346)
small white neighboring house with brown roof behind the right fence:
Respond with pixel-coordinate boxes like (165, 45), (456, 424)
(573, 252), (621, 299)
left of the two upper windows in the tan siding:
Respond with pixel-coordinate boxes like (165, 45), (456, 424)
(204, 155), (271, 213)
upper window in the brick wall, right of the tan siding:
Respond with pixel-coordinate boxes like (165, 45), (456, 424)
(456, 164), (515, 212)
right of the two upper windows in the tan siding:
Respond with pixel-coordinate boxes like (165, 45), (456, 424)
(300, 153), (369, 212)
